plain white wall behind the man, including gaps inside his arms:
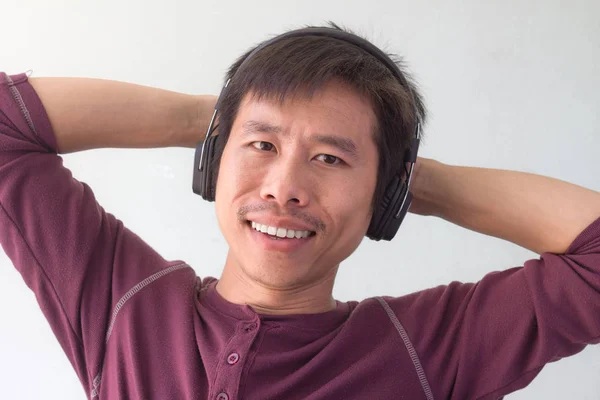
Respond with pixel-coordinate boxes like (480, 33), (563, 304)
(0, 0), (600, 400)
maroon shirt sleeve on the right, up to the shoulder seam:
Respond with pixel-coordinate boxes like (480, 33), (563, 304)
(388, 214), (600, 400)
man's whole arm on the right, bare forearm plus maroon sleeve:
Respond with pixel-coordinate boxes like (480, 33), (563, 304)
(388, 159), (600, 400)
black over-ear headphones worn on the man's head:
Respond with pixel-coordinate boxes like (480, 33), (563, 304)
(192, 28), (421, 240)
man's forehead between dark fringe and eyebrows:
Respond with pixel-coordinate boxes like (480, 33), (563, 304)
(232, 82), (377, 142)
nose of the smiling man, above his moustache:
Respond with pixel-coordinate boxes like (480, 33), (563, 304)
(260, 157), (312, 208)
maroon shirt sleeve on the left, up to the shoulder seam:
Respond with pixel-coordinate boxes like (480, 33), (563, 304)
(0, 73), (180, 393)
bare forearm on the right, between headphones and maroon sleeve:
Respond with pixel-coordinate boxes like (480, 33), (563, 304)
(411, 158), (600, 254)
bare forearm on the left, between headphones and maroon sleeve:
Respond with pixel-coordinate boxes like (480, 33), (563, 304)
(29, 78), (216, 153)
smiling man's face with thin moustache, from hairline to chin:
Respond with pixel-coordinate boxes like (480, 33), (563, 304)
(216, 82), (378, 289)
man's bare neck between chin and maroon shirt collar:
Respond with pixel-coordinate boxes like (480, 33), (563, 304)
(216, 257), (338, 315)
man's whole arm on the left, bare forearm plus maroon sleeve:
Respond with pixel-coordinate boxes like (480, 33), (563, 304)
(0, 72), (214, 397)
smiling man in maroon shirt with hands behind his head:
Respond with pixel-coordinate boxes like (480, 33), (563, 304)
(0, 25), (600, 400)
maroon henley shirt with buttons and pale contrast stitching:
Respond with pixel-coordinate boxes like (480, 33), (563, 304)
(0, 73), (600, 400)
